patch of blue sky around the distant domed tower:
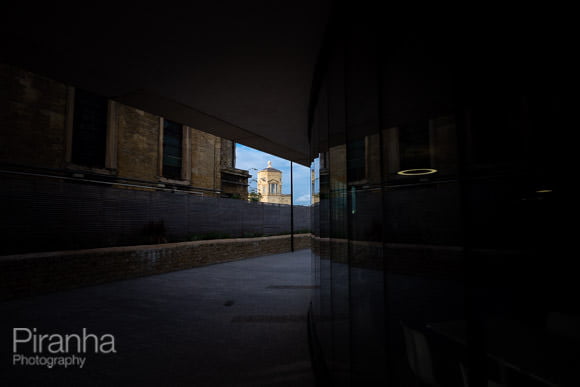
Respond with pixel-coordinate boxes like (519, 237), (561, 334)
(236, 144), (310, 206)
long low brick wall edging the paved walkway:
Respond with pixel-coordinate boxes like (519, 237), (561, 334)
(0, 234), (311, 300)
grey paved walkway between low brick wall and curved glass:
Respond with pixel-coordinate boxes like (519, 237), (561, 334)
(0, 250), (314, 386)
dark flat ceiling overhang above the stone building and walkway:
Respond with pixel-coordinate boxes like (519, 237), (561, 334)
(0, 0), (329, 165)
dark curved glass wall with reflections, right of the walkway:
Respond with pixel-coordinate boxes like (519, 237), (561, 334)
(309, 6), (568, 386)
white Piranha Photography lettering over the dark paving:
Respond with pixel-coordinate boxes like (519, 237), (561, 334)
(12, 328), (117, 368)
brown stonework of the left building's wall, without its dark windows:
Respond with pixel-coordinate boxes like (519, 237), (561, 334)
(0, 64), (241, 196)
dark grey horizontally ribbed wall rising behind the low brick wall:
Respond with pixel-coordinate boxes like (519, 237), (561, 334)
(0, 173), (310, 255)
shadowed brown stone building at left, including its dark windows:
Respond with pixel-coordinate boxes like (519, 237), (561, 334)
(0, 65), (249, 199)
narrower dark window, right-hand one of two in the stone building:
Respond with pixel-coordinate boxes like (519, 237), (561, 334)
(162, 120), (183, 180)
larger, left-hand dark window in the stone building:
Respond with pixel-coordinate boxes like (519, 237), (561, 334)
(70, 89), (108, 168)
